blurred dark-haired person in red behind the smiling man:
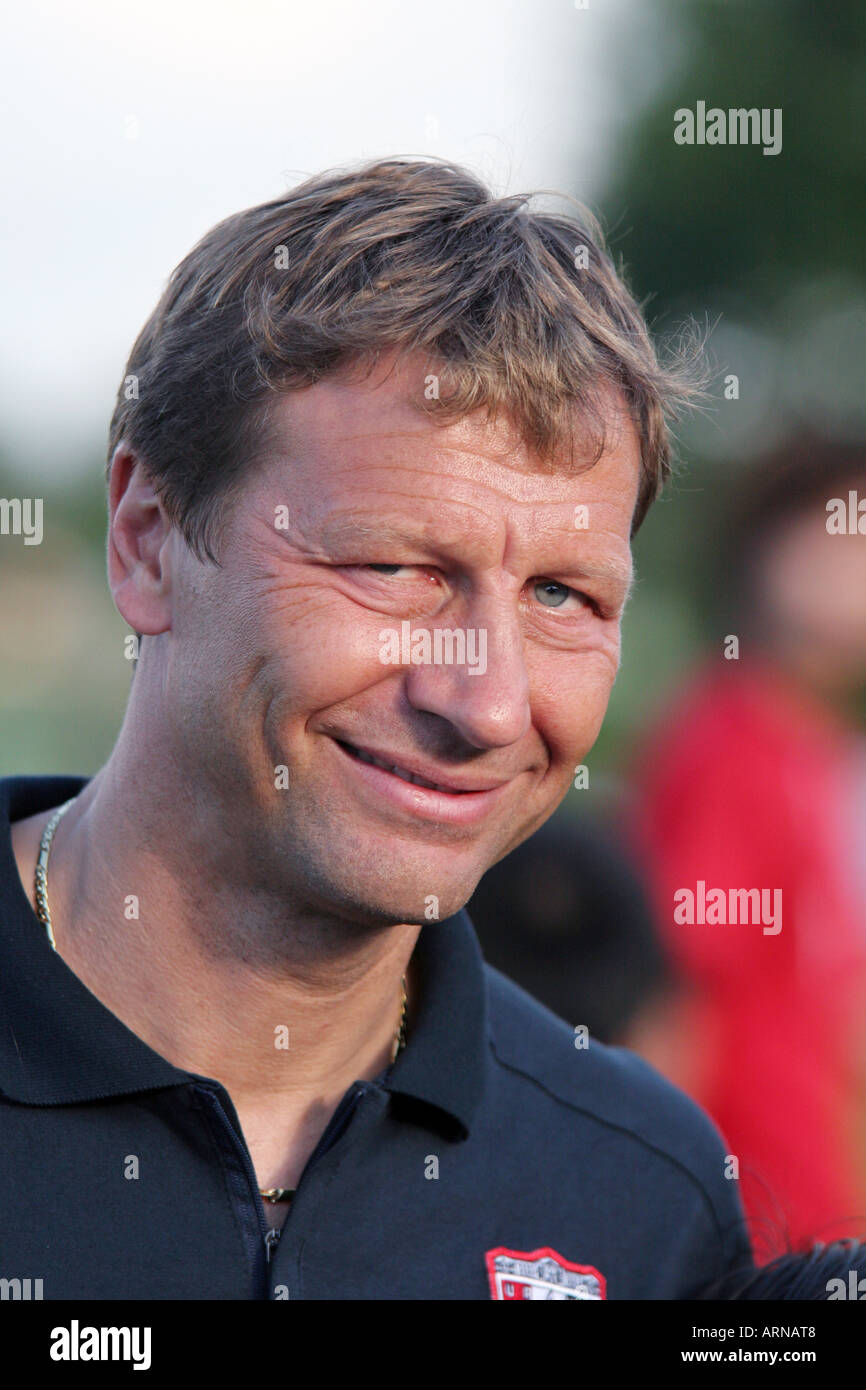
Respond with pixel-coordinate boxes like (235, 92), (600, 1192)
(625, 435), (866, 1257)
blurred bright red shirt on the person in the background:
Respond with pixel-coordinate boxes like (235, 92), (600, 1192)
(637, 660), (866, 1258)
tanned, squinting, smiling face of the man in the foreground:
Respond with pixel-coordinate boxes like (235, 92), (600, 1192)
(154, 364), (639, 923)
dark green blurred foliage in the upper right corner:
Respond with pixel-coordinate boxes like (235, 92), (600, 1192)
(601, 0), (866, 321)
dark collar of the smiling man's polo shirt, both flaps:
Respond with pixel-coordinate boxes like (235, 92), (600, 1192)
(0, 777), (487, 1137)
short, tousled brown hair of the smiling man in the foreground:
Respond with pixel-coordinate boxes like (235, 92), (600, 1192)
(108, 160), (700, 562)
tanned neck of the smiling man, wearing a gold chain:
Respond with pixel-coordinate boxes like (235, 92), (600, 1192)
(14, 744), (420, 1113)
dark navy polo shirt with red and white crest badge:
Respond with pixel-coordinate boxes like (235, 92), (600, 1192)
(0, 777), (751, 1301)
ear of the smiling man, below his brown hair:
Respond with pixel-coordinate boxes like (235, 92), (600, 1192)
(107, 442), (174, 635)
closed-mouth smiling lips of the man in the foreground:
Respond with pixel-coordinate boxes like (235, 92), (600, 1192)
(331, 735), (512, 826)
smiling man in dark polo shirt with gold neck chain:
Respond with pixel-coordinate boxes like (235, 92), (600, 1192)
(0, 161), (749, 1300)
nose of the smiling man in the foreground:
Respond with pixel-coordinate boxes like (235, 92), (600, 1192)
(406, 602), (531, 748)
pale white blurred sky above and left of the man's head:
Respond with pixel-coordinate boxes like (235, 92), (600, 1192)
(0, 0), (659, 480)
